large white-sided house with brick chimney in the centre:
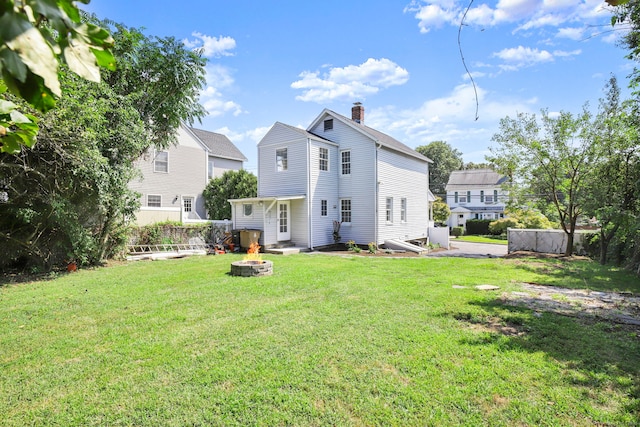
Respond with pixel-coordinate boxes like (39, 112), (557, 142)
(230, 103), (432, 249)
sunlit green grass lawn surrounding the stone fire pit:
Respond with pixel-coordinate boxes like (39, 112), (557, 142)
(0, 254), (640, 426)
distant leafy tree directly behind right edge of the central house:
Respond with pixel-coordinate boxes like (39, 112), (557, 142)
(416, 141), (464, 196)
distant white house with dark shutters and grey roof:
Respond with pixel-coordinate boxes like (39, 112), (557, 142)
(445, 169), (508, 231)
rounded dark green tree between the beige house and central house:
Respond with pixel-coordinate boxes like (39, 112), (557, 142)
(202, 169), (258, 219)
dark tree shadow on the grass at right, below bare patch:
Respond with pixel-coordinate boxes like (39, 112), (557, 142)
(448, 299), (640, 419)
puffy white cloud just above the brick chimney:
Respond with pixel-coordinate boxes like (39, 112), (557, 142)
(291, 58), (409, 104)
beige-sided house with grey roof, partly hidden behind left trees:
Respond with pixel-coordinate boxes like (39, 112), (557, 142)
(129, 125), (247, 225)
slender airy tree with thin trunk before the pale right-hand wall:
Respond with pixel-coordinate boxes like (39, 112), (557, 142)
(488, 108), (598, 256)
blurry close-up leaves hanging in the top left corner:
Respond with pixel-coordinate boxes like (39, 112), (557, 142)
(0, 0), (115, 153)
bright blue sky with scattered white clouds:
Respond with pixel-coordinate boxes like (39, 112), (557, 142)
(81, 0), (633, 173)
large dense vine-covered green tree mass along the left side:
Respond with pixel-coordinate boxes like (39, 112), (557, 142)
(0, 22), (204, 268)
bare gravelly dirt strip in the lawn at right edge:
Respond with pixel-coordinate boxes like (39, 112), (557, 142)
(501, 283), (640, 328)
